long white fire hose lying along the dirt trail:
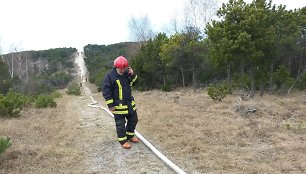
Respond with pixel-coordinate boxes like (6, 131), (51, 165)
(88, 96), (186, 174)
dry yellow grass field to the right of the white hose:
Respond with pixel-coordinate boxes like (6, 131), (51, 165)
(135, 89), (306, 174)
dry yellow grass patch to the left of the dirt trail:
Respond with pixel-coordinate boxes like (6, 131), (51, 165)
(0, 92), (84, 174)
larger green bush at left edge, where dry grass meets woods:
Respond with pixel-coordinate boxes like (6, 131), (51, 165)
(0, 91), (31, 117)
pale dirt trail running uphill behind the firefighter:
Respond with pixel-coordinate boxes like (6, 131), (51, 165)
(73, 54), (173, 174)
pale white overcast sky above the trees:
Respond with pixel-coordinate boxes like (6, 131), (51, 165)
(0, 0), (306, 54)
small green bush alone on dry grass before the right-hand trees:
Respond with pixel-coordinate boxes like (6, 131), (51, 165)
(207, 83), (229, 102)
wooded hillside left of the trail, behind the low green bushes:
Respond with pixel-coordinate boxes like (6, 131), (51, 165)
(0, 48), (77, 95)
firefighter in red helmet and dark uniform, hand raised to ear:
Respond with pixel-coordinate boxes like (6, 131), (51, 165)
(102, 56), (139, 149)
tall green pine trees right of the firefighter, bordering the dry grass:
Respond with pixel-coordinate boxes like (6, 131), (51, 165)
(131, 0), (306, 96)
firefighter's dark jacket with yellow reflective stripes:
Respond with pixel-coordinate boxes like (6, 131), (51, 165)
(102, 68), (138, 114)
